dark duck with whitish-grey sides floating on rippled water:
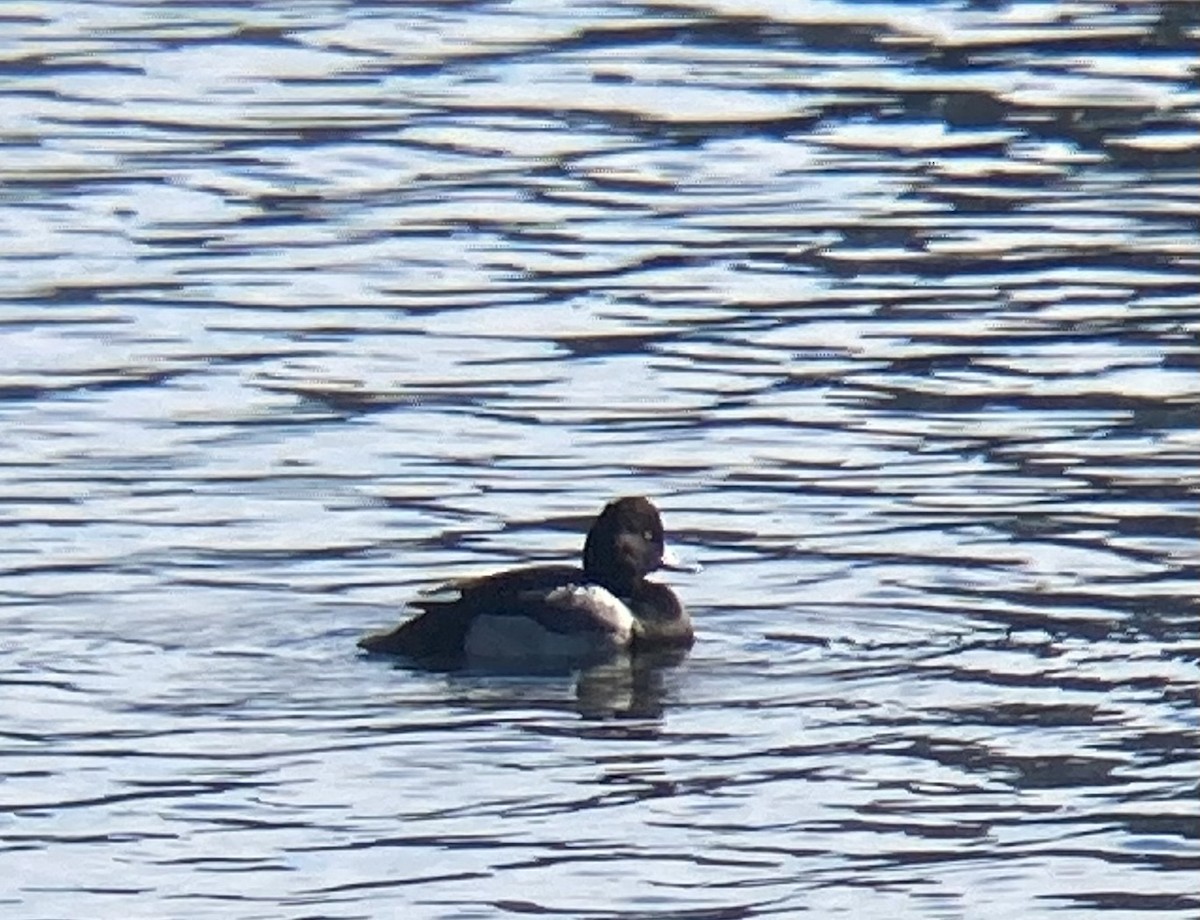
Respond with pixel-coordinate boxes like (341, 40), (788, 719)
(359, 495), (697, 663)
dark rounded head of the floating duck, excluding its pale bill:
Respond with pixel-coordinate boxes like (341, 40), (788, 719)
(583, 497), (681, 597)
